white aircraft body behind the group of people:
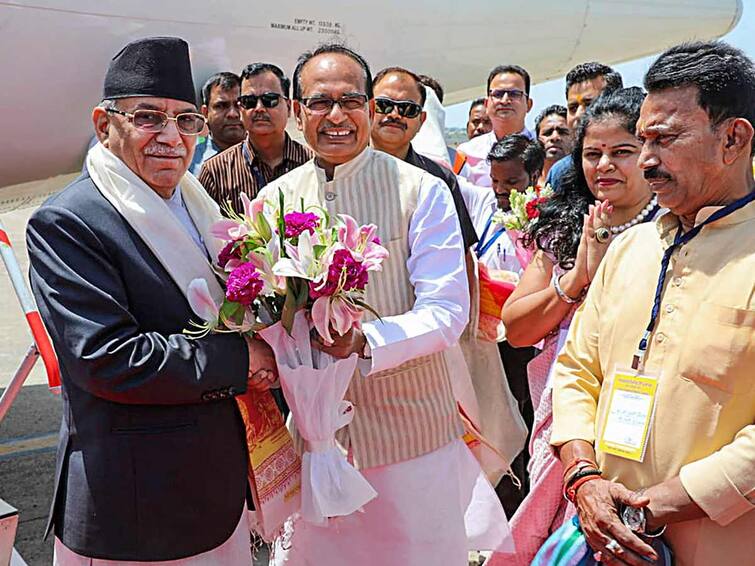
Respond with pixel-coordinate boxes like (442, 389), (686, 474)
(0, 0), (742, 211)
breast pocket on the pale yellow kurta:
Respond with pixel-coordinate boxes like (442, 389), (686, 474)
(679, 302), (755, 393)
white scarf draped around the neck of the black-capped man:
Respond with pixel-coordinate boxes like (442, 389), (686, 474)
(86, 143), (224, 304)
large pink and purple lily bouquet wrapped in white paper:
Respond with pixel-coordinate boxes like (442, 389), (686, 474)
(189, 192), (388, 523)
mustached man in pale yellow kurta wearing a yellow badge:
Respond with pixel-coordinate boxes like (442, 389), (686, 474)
(551, 42), (755, 566)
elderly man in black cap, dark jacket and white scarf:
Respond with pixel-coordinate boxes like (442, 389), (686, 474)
(27, 37), (275, 566)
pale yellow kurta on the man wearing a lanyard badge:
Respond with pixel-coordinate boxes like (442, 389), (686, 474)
(551, 203), (755, 566)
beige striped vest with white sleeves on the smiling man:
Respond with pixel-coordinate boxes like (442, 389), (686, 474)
(259, 148), (469, 468)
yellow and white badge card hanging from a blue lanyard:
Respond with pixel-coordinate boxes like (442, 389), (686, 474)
(598, 370), (658, 462)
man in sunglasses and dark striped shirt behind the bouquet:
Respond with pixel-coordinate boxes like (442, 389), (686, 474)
(199, 63), (312, 212)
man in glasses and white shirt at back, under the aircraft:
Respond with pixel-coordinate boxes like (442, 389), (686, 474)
(458, 65), (535, 187)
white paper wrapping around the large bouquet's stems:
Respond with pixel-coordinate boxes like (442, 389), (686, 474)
(259, 311), (377, 524)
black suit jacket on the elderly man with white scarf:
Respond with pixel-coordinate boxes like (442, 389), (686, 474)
(27, 171), (249, 561)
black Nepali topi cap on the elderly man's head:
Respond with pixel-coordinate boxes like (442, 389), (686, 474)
(102, 37), (197, 104)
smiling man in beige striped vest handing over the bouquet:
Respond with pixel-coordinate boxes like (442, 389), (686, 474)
(260, 45), (508, 566)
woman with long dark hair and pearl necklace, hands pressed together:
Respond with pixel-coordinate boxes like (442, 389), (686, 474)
(491, 87), (659, 566)
